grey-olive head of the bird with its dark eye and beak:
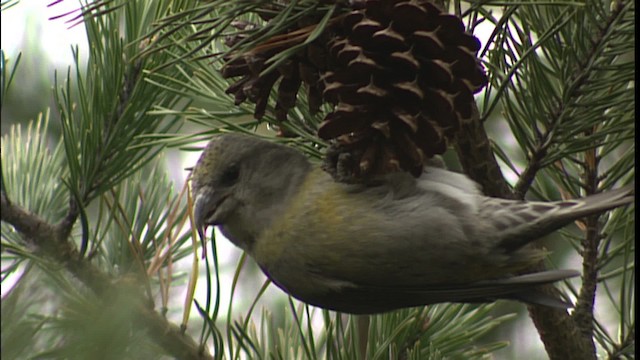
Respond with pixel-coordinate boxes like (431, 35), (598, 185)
(191, 134), (311, 250)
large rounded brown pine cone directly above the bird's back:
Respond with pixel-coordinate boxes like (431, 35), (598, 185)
(318, 0), (487, 178)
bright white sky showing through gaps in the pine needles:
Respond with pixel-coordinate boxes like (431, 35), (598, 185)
(1, 0), (615, 359)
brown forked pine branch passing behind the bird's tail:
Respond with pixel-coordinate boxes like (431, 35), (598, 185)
(456, 1), (633, 360)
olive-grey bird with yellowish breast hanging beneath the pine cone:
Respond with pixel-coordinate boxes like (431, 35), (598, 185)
(191, 133), (635, 314)
